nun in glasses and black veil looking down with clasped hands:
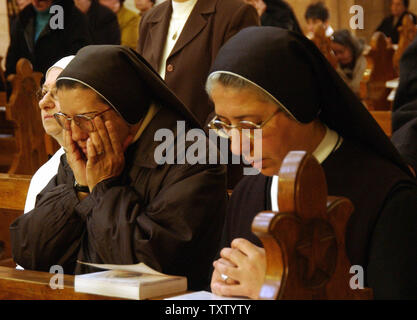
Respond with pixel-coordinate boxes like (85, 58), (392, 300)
(207, 27), (417, 299)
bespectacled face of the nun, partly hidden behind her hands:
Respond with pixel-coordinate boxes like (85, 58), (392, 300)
(58, 88), (129, 156)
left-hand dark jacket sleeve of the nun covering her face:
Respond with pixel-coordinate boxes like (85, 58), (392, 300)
(10, 158), (85, 273)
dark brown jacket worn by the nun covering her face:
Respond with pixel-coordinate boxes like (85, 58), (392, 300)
(10, 152), (226, 289)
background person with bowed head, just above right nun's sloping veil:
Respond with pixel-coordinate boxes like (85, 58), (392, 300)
(331, 29), (367, 96)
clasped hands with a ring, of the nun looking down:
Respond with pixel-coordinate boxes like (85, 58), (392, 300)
(211, 238), (266, 299)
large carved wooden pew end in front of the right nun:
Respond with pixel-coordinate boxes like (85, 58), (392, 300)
(252, 151), (372, 299)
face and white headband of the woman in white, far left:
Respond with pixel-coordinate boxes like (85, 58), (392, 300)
(39, 67), (62, 139)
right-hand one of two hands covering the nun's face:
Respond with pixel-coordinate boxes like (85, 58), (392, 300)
(86, 117), (132, 192)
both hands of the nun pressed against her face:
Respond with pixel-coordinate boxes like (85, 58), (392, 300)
(64, 117), (132, 192)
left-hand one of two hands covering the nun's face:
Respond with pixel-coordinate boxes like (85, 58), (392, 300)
(63, 130), (87, 186)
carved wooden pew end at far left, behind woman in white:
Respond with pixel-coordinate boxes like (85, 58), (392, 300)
(0, 58), (48, 174)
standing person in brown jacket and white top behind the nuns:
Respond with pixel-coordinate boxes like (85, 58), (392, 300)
(137, 0), (259, 188)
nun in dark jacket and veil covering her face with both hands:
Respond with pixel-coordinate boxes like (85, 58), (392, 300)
(10, 45), (227, 290)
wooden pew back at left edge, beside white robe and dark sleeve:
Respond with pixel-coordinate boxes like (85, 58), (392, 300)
(0, 173), (32, 266)
